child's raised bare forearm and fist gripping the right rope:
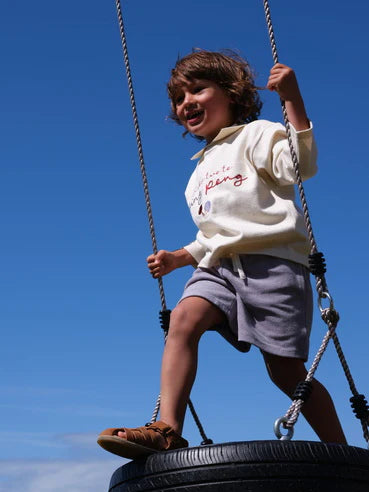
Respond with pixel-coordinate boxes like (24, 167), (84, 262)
(267, 63), (310, 131)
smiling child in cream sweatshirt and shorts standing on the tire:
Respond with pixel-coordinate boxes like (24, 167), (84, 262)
(98, 51), (346, 458)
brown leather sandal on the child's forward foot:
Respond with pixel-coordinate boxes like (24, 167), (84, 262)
(97, 420), (188, 459)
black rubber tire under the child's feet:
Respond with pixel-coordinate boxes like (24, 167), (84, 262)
(109, 440), (369, 492)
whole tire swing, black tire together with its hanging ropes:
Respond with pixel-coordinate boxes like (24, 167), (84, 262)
(109, 0), (369, 492)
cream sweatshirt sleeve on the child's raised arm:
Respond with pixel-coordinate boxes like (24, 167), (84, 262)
(249, 122), (317, 186)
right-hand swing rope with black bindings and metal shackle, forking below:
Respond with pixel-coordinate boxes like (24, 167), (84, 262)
(263, 0), (369, 444)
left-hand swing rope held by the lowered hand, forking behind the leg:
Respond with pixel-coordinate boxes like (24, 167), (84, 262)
(115, 0), (212, 444)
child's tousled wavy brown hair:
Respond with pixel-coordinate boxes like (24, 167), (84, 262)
(167, 49), (262, 133)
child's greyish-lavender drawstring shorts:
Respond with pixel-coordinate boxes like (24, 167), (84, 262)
(180, 255), (313, 361)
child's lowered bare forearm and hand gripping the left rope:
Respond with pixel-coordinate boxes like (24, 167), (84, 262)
(147, 248), (196, 278)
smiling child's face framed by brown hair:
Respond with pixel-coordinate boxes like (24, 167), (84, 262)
(174, 79), (233, 143)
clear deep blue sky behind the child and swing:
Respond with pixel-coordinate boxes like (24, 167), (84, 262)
(0, 0), (369, 492)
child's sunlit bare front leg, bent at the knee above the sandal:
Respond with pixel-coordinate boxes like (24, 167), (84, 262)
(118, 297), (225, 437)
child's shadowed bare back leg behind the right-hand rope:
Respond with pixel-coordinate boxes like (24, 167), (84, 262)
(263, 352), (347, 444)
